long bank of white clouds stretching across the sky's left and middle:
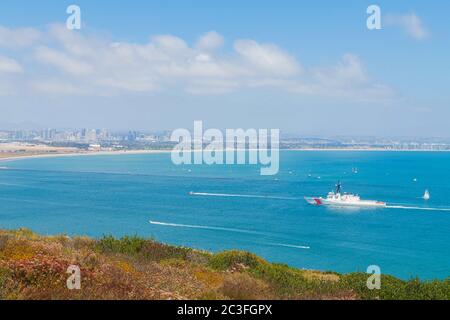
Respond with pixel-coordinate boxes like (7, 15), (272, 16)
(0, 25), (392, 98)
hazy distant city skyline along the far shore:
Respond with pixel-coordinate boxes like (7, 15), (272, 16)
(0, 128), (450, 151)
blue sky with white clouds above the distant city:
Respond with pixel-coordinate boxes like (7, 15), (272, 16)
(0, 0), (450, 137)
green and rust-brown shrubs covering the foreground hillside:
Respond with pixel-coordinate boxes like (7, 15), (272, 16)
(0, 229), (450, 300)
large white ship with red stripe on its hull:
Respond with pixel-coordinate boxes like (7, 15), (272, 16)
(305, 181), (386, 207)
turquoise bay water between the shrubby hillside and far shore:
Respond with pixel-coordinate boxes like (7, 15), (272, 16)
(0, 151), (450, 279)
